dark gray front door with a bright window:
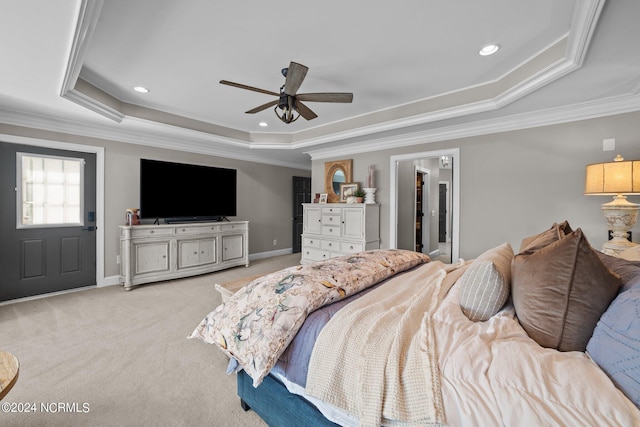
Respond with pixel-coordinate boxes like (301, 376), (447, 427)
(0, 142), (96, 301)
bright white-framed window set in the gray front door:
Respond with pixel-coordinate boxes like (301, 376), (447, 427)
(16, 153), (84, 228)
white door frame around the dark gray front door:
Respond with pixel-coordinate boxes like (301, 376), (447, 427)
(0, 134), (105, 286)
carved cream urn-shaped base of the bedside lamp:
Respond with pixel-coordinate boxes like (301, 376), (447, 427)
(600, 194), (640, 256)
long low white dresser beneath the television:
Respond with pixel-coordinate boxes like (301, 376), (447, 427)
(120, 221), (249, 290)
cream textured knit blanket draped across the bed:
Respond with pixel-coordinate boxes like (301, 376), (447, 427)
(305, 262), (464, 426)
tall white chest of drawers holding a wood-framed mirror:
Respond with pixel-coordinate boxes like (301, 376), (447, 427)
(300, 203), (380, 264)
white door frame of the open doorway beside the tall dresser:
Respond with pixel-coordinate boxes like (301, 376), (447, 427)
(389, 148), (461, 262)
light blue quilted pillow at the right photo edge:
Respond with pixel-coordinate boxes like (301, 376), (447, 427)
(587, 282), (640, 409)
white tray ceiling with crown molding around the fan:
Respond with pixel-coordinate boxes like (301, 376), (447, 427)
(0, 0), (640, 167)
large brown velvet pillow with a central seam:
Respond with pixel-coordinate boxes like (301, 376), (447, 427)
(511, 229), (621, 351)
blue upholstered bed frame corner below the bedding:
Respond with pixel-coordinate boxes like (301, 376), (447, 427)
(237, 371), (337, 427)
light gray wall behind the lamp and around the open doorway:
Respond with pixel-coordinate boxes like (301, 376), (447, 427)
(311, 112), (640, 258)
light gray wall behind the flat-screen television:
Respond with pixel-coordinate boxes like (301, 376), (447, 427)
(0, 124), (311, 277)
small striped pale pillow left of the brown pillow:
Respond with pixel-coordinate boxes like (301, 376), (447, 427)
(458, 243), (513, 322)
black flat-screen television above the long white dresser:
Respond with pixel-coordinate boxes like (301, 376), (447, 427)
(140, 159), (237, 222)
